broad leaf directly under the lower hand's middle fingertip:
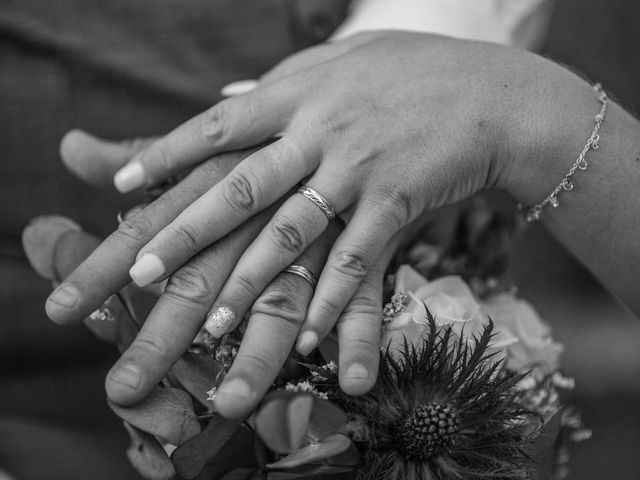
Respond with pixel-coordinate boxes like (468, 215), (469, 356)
(109, 387), (200, 445)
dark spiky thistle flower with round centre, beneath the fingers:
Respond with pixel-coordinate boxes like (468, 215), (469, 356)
(315, 313), (530, 480)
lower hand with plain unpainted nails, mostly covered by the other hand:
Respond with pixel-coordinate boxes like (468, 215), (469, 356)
(47, 132), (391, 417)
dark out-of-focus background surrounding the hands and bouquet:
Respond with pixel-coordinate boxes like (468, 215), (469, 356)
(0, 0), (640, 480)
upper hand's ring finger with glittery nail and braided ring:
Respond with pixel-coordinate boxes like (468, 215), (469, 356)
(204, 177), (350, 337)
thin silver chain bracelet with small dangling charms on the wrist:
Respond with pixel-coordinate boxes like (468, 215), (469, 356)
(518, 83), (609, 222)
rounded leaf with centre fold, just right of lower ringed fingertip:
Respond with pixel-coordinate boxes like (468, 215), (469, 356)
(255, 391), (314, 453)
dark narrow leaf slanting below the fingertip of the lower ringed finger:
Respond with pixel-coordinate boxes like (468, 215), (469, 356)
(171, 415), (241, 478)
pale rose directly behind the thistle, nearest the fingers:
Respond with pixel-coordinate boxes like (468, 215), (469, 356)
(382, 265), (518, 357)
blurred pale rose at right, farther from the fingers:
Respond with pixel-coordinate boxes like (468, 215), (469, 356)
(482, 293), (562, 372)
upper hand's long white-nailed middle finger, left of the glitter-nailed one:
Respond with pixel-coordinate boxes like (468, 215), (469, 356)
(130, 138), (316, 293)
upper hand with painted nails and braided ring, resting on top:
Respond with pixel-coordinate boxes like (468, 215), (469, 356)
(102, 33), (548, 364)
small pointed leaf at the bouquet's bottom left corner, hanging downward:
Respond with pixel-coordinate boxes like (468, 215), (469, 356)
(123, 422), (176, 480)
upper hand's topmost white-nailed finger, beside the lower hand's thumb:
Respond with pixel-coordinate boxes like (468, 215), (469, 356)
(114, 85), (295, 193)
